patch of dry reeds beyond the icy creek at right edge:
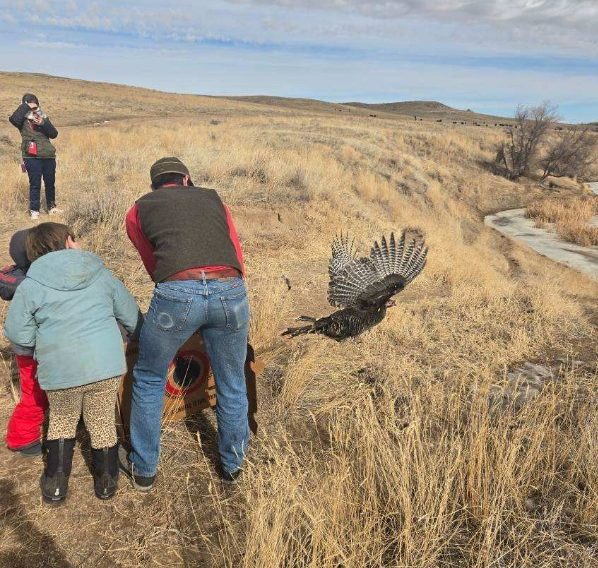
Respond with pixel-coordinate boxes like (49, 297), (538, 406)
(526, 196), (598, 246)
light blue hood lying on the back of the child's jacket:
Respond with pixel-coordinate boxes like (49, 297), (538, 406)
(27, 249), (105, 290)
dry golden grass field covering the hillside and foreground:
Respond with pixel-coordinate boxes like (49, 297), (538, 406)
(0, 75), (598, 568)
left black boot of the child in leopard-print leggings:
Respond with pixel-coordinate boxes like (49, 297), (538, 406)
(39, 438), (75, 505)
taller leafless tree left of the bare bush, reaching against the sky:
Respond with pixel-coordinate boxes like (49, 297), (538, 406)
(496, 103), (558, 179)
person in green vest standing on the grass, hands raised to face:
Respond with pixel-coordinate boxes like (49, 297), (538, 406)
(8, 93), (60, 219)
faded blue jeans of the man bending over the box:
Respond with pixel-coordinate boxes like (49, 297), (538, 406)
(129, 278), (249, 476)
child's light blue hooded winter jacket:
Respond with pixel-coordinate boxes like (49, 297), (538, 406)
(4, 249), (141, 390)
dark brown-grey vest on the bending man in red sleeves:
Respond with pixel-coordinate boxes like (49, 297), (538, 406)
(137, 186), (242, 282)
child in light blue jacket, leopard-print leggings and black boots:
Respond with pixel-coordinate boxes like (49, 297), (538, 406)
(5, 223), (141, 503)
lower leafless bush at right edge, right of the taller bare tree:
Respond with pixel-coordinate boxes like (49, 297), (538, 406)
(539, 126), (596, 180)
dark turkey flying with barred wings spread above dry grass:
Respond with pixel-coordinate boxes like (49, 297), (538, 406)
(282, 228), (428, 341)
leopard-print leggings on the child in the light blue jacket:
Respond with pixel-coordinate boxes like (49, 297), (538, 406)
(46, 377), (120, 449)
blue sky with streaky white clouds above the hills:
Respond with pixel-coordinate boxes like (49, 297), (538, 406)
(0, 0), (598, 122)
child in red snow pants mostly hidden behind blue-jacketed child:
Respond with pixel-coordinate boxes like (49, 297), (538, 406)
(0, 229), (48, 457)
